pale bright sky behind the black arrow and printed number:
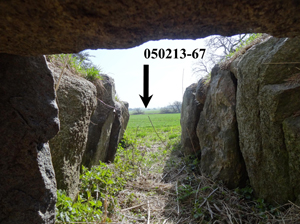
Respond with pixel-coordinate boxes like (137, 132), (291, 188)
(83, 39), (208, 108)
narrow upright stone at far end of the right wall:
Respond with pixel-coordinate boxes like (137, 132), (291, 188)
(180, 83), (203, 155)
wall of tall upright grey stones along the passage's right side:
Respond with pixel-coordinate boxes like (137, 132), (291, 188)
(182, 37), (300, 204)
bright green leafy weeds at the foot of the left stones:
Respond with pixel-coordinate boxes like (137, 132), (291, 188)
(56, 162), (128, 222)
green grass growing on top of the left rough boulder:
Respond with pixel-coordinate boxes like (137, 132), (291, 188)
(47, 53), (101, 82)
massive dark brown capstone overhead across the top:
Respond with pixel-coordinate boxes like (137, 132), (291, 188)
(0, 0), (300, 55)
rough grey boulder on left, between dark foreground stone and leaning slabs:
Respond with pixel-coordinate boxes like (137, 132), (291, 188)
(49, 60), (97, 199)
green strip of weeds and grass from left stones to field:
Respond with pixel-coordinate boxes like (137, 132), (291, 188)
(56, 114), (180, 223)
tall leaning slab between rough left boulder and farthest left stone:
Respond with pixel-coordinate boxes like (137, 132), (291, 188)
(83, 75), (116, 167)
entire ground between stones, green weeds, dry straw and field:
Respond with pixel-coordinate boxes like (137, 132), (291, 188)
(56, 114), (300, 224)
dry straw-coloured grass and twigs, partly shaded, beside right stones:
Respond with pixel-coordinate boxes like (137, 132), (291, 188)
(103, 141), (300, 224)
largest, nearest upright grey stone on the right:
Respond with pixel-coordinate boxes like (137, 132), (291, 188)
(233, 38), (300, 204)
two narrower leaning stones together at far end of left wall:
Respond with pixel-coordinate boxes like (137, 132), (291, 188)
(83, 75), (129, 167)
